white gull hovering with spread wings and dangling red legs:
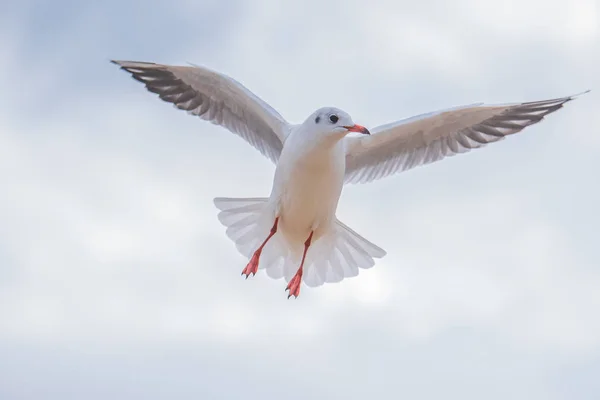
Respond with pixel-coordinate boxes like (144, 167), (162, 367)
(110, 60), (589, 299)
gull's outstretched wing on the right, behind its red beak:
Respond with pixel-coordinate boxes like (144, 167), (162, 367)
(345, 92), (587, 183)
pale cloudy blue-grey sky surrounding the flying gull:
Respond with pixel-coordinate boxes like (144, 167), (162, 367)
(0, 0), (600, 400)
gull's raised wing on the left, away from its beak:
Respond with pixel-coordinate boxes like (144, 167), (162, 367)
(112, 60), (289, 162)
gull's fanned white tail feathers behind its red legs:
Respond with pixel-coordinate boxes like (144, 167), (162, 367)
(214, 197), (386, 287)
